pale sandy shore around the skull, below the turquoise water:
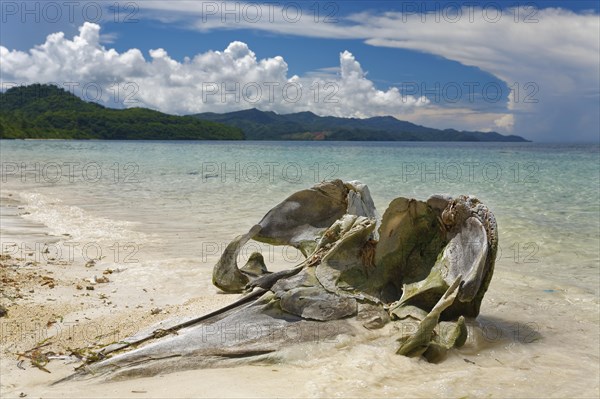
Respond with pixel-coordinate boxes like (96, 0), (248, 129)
(0, 191), (600, 398)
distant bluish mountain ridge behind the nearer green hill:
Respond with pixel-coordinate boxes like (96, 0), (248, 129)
(193, 108), (528, 142)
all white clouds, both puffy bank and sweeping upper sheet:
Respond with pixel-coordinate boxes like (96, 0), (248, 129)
(0, 1), (600, 141)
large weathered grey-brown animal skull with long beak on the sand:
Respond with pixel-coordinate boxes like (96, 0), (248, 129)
(58, 180), (498, 378)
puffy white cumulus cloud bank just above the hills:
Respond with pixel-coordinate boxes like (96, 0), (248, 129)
(0, 22), (428, 117)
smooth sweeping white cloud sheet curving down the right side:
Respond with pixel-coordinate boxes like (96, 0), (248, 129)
(132, 1), (600, 141)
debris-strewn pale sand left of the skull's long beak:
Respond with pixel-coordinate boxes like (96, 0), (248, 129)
(0, 197), (247, 398)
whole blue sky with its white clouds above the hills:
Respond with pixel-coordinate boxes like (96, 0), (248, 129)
(0, 0), (600, 142)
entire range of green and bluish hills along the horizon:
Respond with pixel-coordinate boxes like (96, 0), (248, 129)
(0, 84), (527, 141)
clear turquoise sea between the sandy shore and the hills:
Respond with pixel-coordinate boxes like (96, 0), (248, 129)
(0, 141), (600, 291)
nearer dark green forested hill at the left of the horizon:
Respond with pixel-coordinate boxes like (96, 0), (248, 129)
(0, 84), (244, 140)
